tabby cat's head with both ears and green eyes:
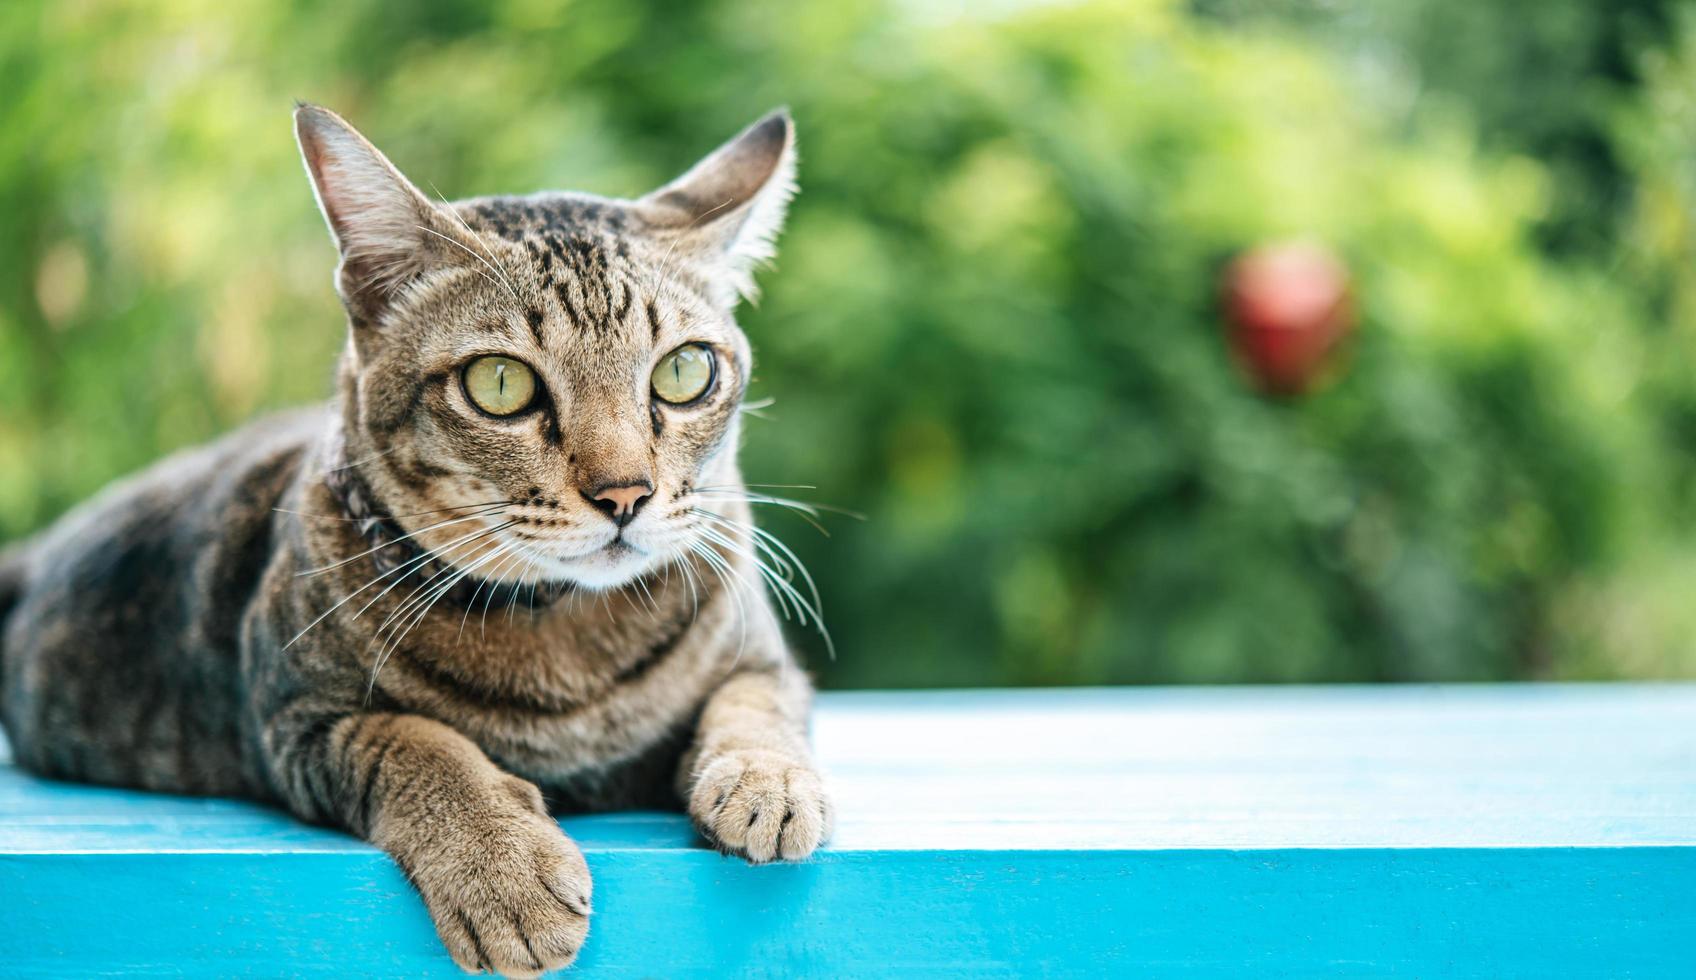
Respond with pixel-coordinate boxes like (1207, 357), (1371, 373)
(295, 105), (795, 588)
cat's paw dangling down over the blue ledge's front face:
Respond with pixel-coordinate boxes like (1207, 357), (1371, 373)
(409, 780), (590, 977)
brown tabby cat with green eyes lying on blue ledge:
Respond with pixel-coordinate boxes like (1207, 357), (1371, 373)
(0, 105), (833, 977)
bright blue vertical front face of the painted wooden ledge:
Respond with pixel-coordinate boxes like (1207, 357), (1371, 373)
(0, 846), (1696, 977)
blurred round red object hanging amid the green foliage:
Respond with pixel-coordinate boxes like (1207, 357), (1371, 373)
(1225, 244), (1355, 395)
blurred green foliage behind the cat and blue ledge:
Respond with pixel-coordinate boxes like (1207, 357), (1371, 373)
(0, 0), (1696, 685)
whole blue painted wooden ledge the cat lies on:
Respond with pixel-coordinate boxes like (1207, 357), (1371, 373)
(0, 685), (1696, 978)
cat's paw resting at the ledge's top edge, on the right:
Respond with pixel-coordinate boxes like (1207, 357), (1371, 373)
(689, 749), (833, 863)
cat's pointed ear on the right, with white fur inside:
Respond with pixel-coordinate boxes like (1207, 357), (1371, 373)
(638, 109), (795, 307)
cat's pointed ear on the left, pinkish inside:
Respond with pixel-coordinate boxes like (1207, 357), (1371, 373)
(295, 105), (453, 320)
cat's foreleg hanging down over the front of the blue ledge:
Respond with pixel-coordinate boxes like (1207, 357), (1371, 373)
(265, 714), (590, 977)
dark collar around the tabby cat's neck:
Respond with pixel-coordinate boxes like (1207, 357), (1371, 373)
(324, 436), (572, 609)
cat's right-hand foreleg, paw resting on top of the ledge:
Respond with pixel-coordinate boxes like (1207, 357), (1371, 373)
(678, 665), (833, 863)
